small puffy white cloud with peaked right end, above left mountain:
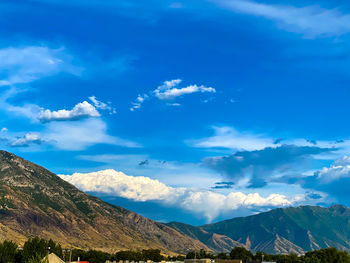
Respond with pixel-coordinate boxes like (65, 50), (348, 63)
(37, 101), (101, 122)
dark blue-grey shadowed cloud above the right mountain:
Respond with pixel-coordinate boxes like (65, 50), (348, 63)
(203, 145), (334, 188)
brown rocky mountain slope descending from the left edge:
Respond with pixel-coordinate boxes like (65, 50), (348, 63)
(0, 151), (208, 253)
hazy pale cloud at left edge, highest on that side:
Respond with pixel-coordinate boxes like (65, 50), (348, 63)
(0, 46), (82, 86)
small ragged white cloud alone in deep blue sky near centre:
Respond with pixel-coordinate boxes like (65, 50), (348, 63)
(130, 79), (216, 111)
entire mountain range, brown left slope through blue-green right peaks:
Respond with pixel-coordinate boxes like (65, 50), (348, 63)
(0, 151), (350, 254)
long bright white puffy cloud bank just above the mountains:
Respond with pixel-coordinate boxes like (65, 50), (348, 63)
(60, 169), (302, 222)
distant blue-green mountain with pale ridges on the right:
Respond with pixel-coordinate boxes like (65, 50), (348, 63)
(169, 205), (350, 254)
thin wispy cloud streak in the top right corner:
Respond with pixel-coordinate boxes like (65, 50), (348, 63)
(212, 0), (350, 37)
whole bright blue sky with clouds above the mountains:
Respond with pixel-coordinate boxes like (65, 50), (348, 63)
(0, 0), (350, 225)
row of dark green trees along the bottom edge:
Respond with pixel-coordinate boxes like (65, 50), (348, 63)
(0, 237), (350, 263)
